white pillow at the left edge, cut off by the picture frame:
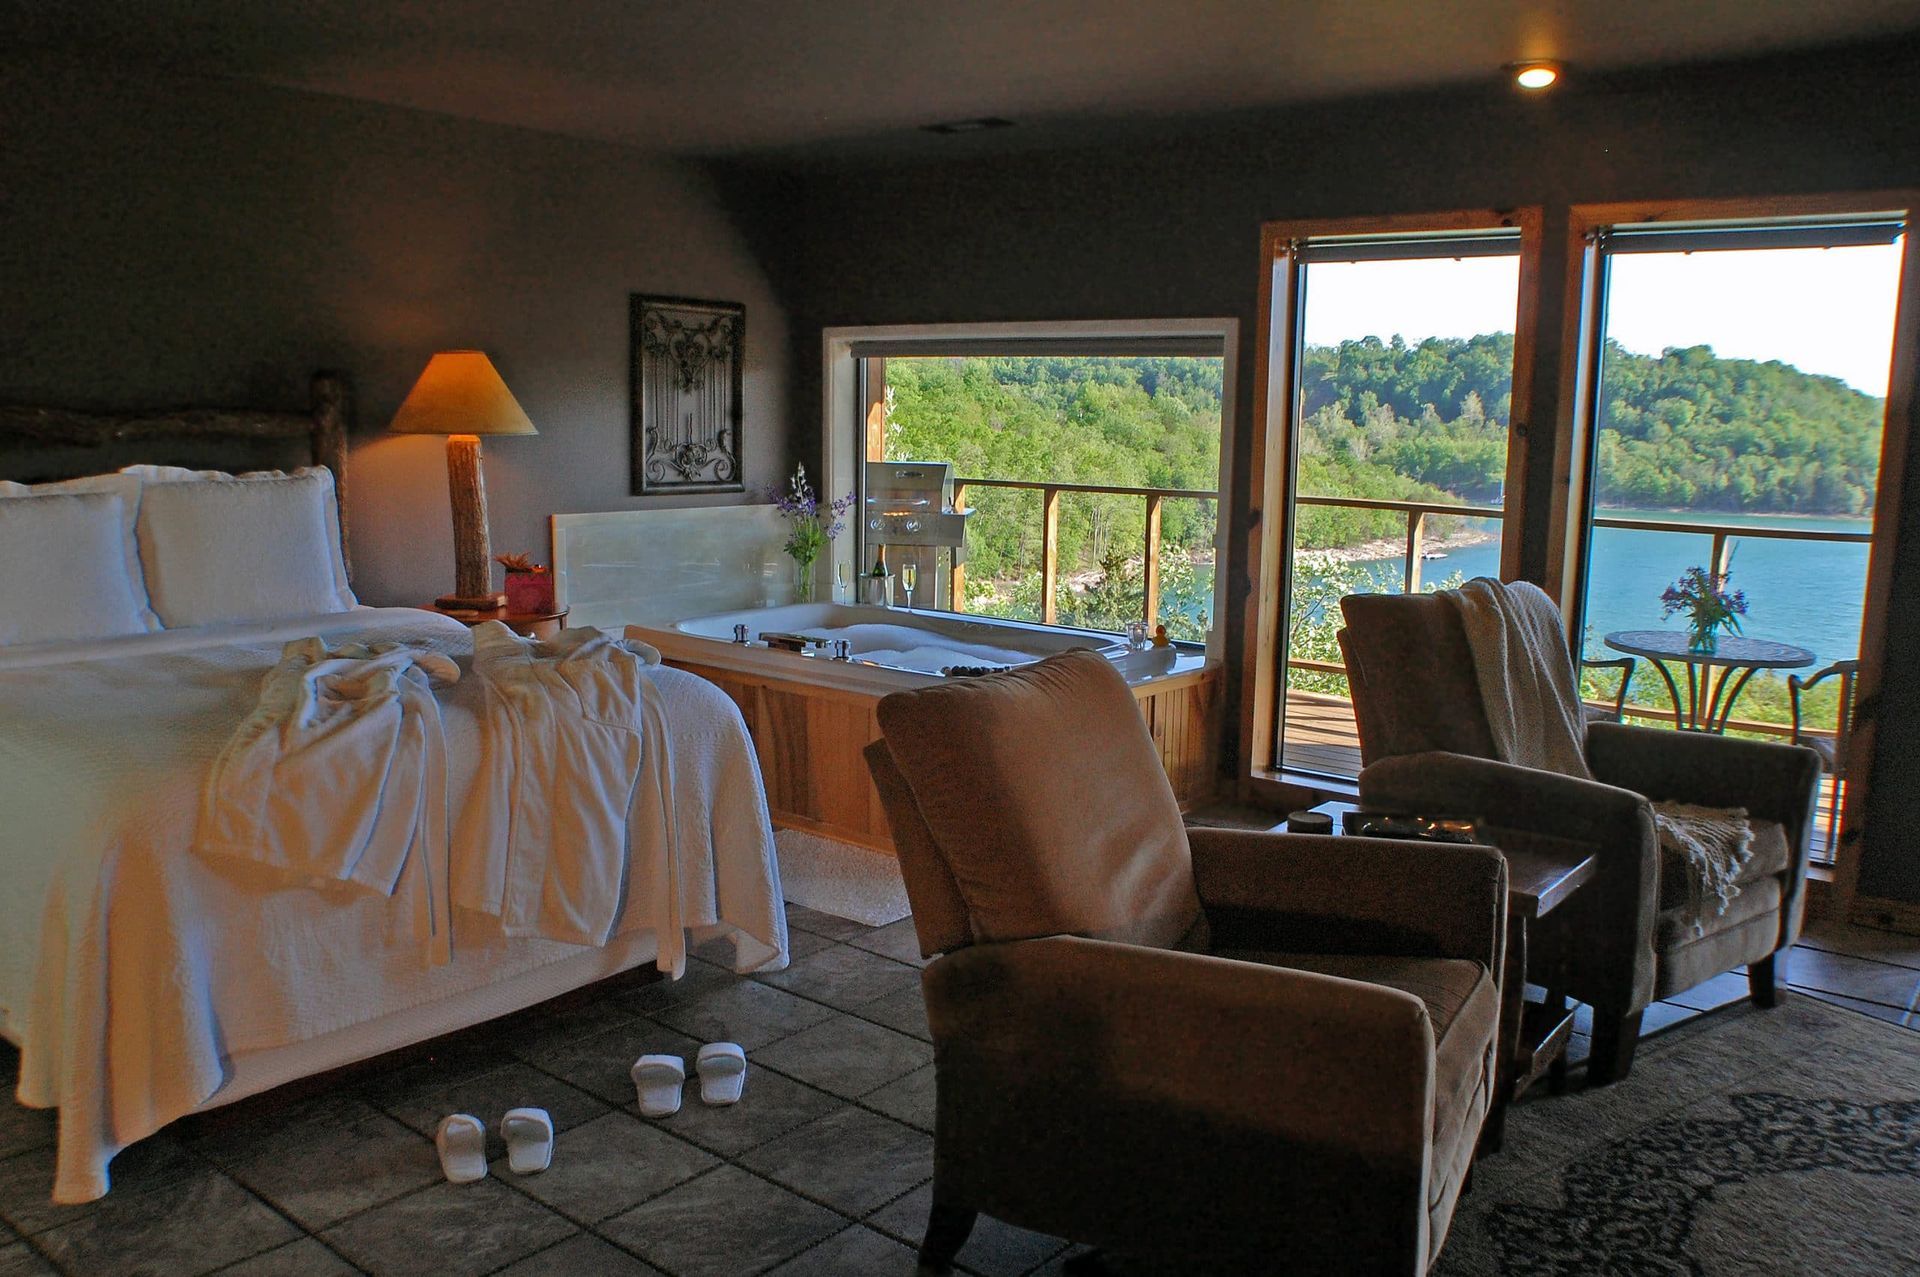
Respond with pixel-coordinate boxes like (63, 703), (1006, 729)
(0, 484), (159, 645)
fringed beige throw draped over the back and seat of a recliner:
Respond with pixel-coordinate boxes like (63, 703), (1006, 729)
(1442, 576), (1753, 935)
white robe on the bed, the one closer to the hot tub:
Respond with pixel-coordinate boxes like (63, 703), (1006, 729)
(453, 620), (674, 956)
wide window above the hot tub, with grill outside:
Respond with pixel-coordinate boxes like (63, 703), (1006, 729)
(829, 321), (1233, 647)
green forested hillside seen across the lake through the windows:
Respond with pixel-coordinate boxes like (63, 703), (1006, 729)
(887, 343), (1882, 632)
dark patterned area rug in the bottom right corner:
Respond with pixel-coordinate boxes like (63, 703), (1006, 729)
(1436, 995), (1920, 1277)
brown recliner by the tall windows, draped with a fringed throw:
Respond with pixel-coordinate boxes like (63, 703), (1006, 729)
(1340, 593), (1820, 1085)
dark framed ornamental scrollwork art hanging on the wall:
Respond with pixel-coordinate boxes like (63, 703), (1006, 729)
(630, 292), (747, 497)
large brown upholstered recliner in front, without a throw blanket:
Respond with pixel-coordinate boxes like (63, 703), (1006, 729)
(868, 653), (1505, 1273)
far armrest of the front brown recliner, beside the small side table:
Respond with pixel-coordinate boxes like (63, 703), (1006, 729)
(1187, 830), (1507, 967)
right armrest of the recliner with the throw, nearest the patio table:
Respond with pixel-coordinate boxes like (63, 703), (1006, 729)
(1586, 722), (1820, 839)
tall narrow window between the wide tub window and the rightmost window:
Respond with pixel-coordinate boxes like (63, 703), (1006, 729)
(1252, 213), (1538, 783)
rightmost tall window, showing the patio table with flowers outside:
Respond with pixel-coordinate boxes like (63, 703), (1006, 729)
(1571, 213), (1905, 862)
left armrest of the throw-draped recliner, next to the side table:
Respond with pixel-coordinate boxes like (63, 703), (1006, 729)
(1359, 752), (1653, 856)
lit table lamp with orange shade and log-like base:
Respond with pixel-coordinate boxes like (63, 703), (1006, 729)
(388, 349), (540, 611)
